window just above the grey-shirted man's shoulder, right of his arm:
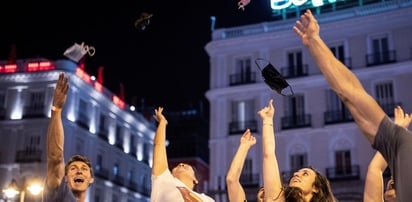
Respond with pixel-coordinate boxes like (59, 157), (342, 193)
(375, 81), (397, 116)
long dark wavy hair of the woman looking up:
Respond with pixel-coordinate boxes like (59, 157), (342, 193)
(284, 166), (337, 202)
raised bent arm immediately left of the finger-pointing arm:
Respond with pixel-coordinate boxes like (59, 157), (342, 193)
(226, 129), (256, 202)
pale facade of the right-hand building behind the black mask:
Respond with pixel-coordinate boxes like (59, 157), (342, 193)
(205, 0), (412, 202)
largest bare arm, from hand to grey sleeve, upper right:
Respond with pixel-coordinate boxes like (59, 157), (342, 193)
(293, 9), (385, 144)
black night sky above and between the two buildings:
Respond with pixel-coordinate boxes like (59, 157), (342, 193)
(0, 0), (271, 109)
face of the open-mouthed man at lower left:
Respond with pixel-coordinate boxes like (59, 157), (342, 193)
(66, 161), (94, 192)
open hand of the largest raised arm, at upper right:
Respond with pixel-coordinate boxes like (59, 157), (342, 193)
(293, 9), (320, 46)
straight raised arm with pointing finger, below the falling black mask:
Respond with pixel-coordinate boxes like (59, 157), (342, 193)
(258, 99), (284, 201)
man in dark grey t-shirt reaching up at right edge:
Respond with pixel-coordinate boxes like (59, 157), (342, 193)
(293, 9), (412, 201)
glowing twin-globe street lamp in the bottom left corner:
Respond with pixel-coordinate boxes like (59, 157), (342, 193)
(3, 179), (43, 202)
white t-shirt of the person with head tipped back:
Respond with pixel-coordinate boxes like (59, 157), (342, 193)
(150, 169), (215, 202)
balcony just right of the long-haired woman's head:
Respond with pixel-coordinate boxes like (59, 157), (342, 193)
(326, 165), (360, 181)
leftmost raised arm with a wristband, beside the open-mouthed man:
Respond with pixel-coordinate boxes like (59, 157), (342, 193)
(46, 73), (69, 189)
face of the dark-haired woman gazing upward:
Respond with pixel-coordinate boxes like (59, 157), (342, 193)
(289, 168), (317, 195)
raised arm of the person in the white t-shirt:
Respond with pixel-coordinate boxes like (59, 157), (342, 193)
(152, 107), (169, 176)
